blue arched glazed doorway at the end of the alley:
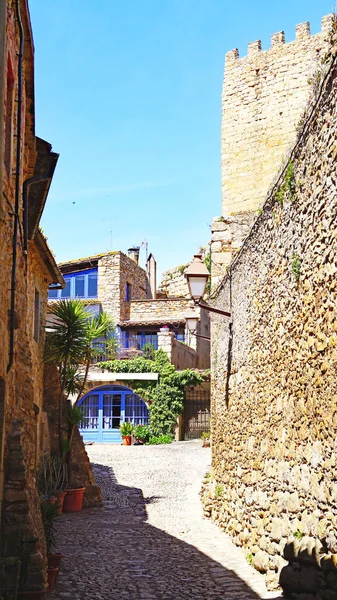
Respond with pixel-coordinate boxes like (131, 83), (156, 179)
(77, 385), (149, 444)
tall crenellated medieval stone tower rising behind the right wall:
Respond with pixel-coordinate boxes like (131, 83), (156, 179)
(211, 15), (334, 287)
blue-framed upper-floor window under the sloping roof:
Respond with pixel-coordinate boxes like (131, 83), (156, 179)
(48, 269), (98, 300)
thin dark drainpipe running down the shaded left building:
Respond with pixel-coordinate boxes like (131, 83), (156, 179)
(7, 0), (24, 373)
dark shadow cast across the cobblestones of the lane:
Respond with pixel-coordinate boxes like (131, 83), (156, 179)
(51, 465), (276, 600)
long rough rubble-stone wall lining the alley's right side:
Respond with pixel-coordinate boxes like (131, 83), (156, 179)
(203, 45), (337, 597)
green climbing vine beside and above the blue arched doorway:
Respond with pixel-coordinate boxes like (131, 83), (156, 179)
(99, 350), (205, 436)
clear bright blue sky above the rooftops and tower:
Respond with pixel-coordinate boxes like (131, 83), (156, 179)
(30, 0), (334, 272)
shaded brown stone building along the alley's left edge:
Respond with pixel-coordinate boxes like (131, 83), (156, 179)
(0, 0), (100, 598)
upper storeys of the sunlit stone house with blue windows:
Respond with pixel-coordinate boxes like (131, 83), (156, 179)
(50, 248), (210, 369)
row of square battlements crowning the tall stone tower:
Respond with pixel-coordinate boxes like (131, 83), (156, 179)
(225, 13), (336, 67)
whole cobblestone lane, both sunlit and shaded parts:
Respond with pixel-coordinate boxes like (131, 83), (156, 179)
(50, 441), (277, 600)
